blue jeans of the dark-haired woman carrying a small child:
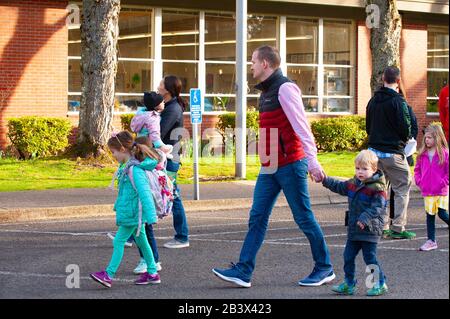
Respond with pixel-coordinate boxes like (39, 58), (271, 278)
(166, 160), (189, 242)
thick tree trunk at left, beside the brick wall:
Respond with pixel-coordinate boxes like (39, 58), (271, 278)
(78, 0), (120, 157)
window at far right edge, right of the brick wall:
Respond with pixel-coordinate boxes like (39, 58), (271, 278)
(427, 26), (449, 113)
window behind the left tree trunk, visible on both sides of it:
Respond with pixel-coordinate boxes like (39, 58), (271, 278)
(68, 8), (152, 112)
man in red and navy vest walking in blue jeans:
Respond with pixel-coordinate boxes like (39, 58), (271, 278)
(212, 46), (335, 288)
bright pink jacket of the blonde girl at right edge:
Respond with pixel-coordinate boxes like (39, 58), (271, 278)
(414, 150), (448, 196)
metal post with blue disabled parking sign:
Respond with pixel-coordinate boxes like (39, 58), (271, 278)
(190, 89), (202, 200)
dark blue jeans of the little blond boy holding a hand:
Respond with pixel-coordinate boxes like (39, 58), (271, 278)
(344, 240), (386, 286)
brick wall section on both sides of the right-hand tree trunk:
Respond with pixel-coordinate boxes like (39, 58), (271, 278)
(356, 21), (432, 144)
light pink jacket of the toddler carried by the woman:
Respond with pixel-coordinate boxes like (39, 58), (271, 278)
(130, 111), (161, 147)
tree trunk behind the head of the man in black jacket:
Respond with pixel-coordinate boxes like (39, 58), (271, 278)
(366, 0), (402, 94)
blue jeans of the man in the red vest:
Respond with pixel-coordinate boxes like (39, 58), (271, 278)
(236, 159), (333, 280)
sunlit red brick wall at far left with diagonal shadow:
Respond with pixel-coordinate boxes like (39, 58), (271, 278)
(0, 0), (68, 148)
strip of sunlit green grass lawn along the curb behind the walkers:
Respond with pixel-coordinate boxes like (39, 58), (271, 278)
(0, 152), (356, 192)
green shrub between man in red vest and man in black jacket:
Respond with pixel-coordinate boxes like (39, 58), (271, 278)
(311, 115), (368, 152)
